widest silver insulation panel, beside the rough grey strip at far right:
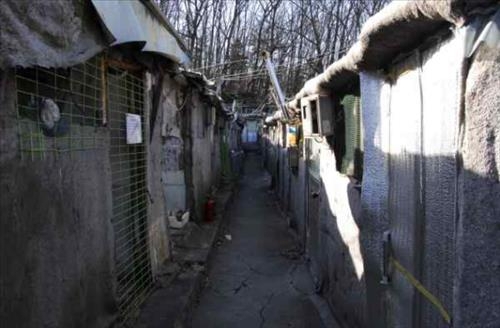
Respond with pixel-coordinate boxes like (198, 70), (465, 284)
(421, 31), (464, 328)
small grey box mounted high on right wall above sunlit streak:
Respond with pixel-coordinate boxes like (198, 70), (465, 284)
(300, 95), (334, 137)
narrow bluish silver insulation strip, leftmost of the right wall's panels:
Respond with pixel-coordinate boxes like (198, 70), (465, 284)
(360, 72), (391, 327)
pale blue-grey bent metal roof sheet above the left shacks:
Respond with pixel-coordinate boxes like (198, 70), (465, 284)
(92, 0), (189, 64)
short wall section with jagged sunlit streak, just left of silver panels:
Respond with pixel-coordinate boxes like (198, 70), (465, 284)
(318, 142), (366, 327)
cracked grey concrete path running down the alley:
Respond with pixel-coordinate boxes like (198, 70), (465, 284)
(192, 153), (323, 328)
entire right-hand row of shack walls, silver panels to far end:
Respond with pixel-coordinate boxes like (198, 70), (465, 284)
(264, 17), (500, 327)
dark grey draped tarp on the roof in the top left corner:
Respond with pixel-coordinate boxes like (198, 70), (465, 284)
(0, 0), (106, 69)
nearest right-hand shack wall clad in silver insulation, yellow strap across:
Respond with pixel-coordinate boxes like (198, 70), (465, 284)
(361, 25), (500, 327)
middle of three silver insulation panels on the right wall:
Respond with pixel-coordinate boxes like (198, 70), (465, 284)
(389, 55), (423, 328)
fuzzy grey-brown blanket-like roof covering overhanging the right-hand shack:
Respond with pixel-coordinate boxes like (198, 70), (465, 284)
(288, 0), (495, 111)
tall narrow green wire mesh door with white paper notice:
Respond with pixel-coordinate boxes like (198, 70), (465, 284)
(106, 66), (153, 322)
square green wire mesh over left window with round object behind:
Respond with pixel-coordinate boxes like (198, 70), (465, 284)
(16, 56), (106, 160)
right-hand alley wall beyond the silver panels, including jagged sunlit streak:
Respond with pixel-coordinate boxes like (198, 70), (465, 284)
(263, 123), (366, 327)
